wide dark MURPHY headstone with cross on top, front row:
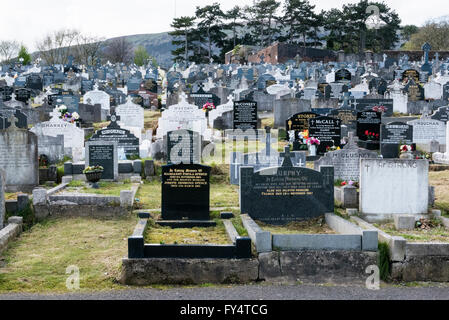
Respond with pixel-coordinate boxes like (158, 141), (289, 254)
(240, 147), (334, 225)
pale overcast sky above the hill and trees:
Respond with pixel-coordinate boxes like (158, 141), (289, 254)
(0, 0), (449, 50)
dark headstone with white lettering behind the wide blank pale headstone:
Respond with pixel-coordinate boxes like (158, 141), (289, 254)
(380, 122), (413, 159)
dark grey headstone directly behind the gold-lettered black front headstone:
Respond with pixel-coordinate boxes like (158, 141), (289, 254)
(166, 130), (201, 164)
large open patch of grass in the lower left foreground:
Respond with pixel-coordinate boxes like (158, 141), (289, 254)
(0, 215), (137, 293)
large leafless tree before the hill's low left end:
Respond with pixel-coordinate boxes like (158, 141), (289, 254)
(36, 29), (80, 64)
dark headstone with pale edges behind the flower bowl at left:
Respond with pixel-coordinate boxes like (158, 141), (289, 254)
(86, 141), (118, 181)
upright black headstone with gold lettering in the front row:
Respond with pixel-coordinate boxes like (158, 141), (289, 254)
(162, 164), (211, 220)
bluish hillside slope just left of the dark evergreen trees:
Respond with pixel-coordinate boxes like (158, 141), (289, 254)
(106, 32), (175, 68)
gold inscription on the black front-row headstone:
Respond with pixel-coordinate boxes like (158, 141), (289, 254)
(164, 169), (207, 188)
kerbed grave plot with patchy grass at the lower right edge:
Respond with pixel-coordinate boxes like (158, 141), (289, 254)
(351, 210), (449, 282)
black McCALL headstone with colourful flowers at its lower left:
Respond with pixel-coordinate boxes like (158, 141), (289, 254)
(309, 117), (341, 155)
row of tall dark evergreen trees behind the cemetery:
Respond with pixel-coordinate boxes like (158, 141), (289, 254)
(169, 0), (447, 63)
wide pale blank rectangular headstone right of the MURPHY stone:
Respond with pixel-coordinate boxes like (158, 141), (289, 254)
(359, 159), (429, 220)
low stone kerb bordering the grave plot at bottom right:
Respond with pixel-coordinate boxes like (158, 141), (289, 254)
(351, 214), (449, 282)
